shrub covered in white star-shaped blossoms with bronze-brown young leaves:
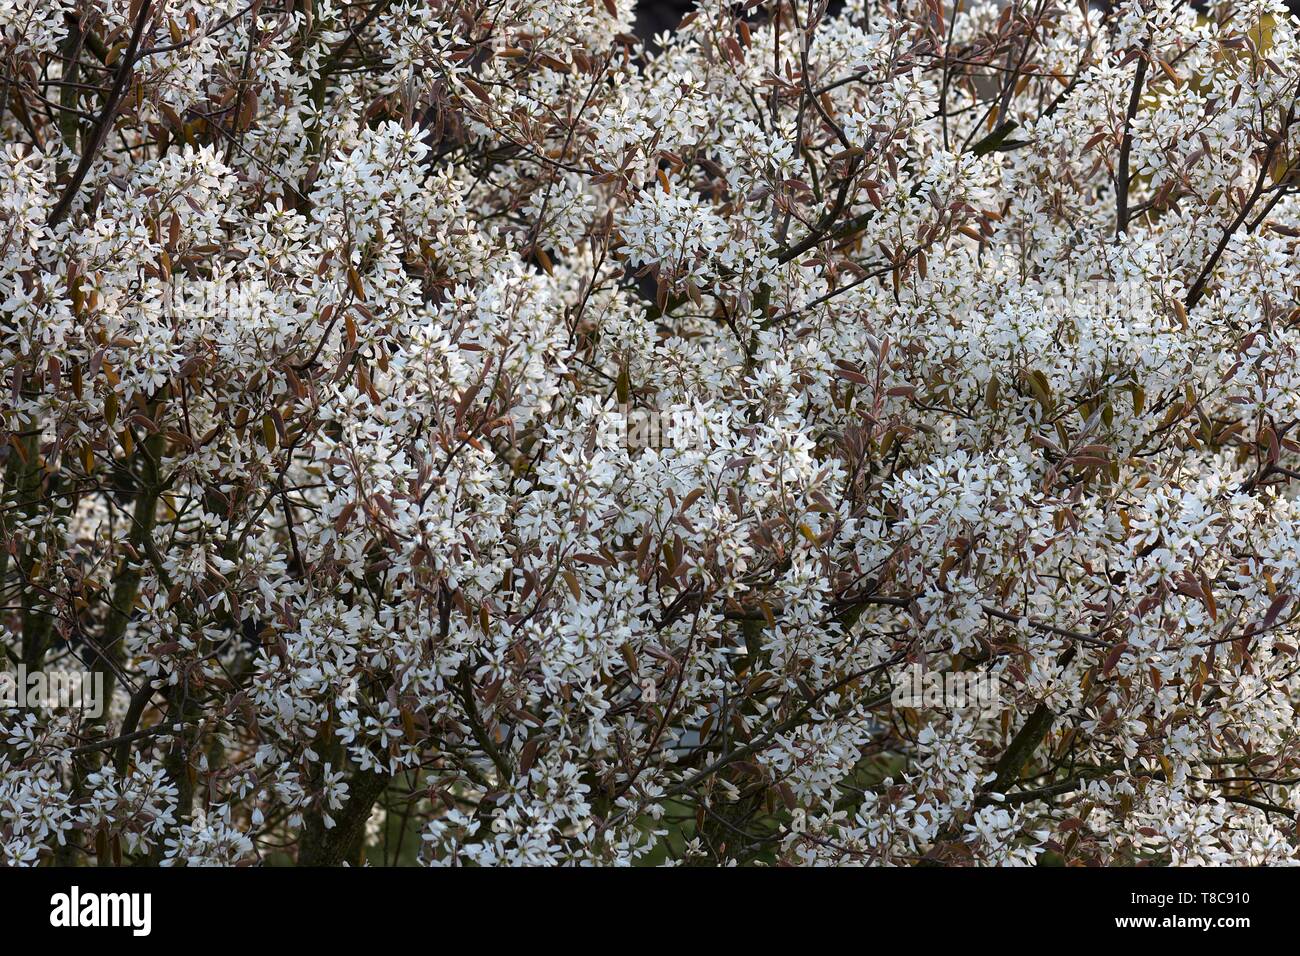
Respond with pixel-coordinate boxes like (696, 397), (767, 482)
(0, 0), (1300, 865)
